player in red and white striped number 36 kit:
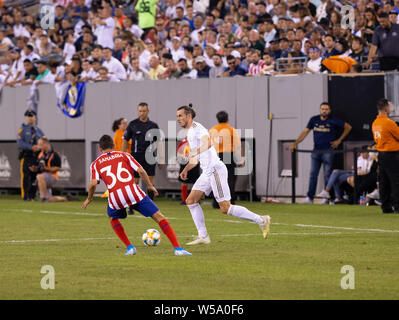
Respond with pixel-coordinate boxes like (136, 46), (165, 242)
(82, 135), (191, 256)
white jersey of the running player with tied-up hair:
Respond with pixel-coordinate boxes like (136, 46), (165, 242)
(187, 121), (221, 175)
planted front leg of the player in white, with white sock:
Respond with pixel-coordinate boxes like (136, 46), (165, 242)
(186, 189), (211, 245)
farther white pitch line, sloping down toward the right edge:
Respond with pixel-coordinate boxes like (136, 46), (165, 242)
(0, 208), (399, 233)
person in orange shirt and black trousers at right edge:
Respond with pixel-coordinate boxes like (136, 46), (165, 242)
(372, 99), (399, 213)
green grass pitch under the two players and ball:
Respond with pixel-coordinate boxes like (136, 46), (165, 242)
(0, 196), (399, 300)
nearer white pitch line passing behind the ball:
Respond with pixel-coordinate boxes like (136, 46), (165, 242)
(0, 232), (388, 244)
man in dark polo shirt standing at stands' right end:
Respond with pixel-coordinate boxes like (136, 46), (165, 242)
(366, 12), (399, 71)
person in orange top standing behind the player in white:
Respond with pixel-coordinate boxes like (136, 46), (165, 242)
(209, 111), (244, 208)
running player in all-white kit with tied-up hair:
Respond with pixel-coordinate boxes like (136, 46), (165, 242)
(177, 104), (270, 245)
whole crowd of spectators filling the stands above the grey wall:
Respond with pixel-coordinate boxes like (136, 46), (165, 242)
(0, 0), (399, 86)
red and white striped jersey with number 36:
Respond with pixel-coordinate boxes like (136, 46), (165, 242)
(90, 151), (146, 210)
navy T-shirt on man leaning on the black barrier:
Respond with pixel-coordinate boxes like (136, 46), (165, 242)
(306, 115), (345, 150)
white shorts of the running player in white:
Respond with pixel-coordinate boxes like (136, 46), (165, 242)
(192, 163), (231, 202)
